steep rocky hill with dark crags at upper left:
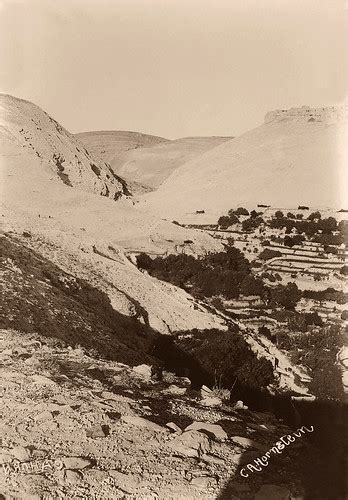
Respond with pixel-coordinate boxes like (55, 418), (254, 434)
(0, 94), (129, 200)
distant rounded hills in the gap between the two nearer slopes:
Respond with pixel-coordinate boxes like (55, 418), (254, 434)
(77, 132), (230, 189)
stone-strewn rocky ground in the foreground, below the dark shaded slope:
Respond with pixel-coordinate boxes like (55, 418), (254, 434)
(0, 330), (326, 499)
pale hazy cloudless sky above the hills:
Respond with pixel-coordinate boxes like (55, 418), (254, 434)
(0, 0), (348, 138)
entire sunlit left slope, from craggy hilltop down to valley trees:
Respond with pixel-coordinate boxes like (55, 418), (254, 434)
(0, 96), (224, 332)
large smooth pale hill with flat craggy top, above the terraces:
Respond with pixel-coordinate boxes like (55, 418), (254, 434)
(145, 107), (348, 218)
